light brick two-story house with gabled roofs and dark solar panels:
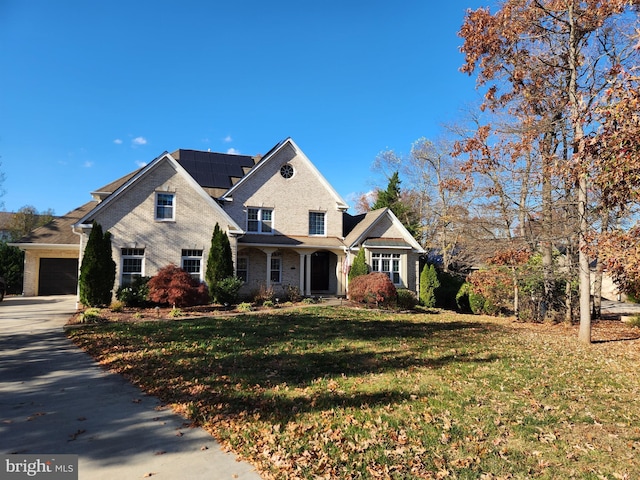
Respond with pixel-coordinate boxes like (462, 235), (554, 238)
(15, 138), (424, 296)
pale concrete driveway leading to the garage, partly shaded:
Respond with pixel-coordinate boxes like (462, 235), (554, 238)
(0, 296), (260, 480)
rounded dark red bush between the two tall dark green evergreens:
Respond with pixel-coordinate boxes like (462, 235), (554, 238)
(148, 265), (209, 307)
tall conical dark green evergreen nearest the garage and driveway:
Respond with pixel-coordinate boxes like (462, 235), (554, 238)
(78, 221), (116, 307)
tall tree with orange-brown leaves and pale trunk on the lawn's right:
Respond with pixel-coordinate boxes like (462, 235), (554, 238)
(460, 0), (638, 343)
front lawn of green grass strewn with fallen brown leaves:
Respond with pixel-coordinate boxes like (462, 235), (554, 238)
(69, 307), (640, 480)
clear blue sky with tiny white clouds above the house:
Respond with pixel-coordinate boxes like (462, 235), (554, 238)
(0, 0), (490, 215)
